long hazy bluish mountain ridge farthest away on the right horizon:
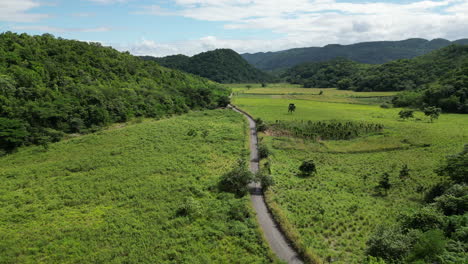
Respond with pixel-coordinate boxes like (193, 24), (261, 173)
(242, 39), (468, 71)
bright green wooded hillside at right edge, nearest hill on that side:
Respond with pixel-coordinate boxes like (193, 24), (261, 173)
(346, 44), (468, 113)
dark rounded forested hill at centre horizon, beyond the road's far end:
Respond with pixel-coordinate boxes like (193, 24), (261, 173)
(141, 49), (272, 83)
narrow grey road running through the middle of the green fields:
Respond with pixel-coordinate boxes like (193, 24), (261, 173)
(229, 105), (302, 264)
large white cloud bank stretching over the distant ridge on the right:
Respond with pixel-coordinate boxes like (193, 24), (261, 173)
(131, 0), (468, 56)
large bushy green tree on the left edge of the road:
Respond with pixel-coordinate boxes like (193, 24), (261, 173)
(219, 160), (254, 197)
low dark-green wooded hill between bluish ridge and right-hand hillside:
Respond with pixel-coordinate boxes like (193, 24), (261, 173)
(282, 58), (371, 88)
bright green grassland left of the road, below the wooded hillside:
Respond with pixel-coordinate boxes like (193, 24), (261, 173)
(0, 110), (271, 263)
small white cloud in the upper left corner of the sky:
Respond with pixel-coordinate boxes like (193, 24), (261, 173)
(0, 0), (48, 22)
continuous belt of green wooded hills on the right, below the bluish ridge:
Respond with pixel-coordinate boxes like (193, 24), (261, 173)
(283, 45), (468, 113)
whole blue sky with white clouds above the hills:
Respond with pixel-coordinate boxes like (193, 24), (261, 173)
(0, 0), (468, 57)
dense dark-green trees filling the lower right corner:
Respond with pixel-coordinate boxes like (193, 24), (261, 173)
(367, 145), (468, 263)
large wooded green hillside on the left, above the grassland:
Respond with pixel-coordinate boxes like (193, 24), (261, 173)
(0, 32), (228, 151)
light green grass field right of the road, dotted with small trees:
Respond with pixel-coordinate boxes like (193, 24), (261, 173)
(233, 85), (468, 263)
